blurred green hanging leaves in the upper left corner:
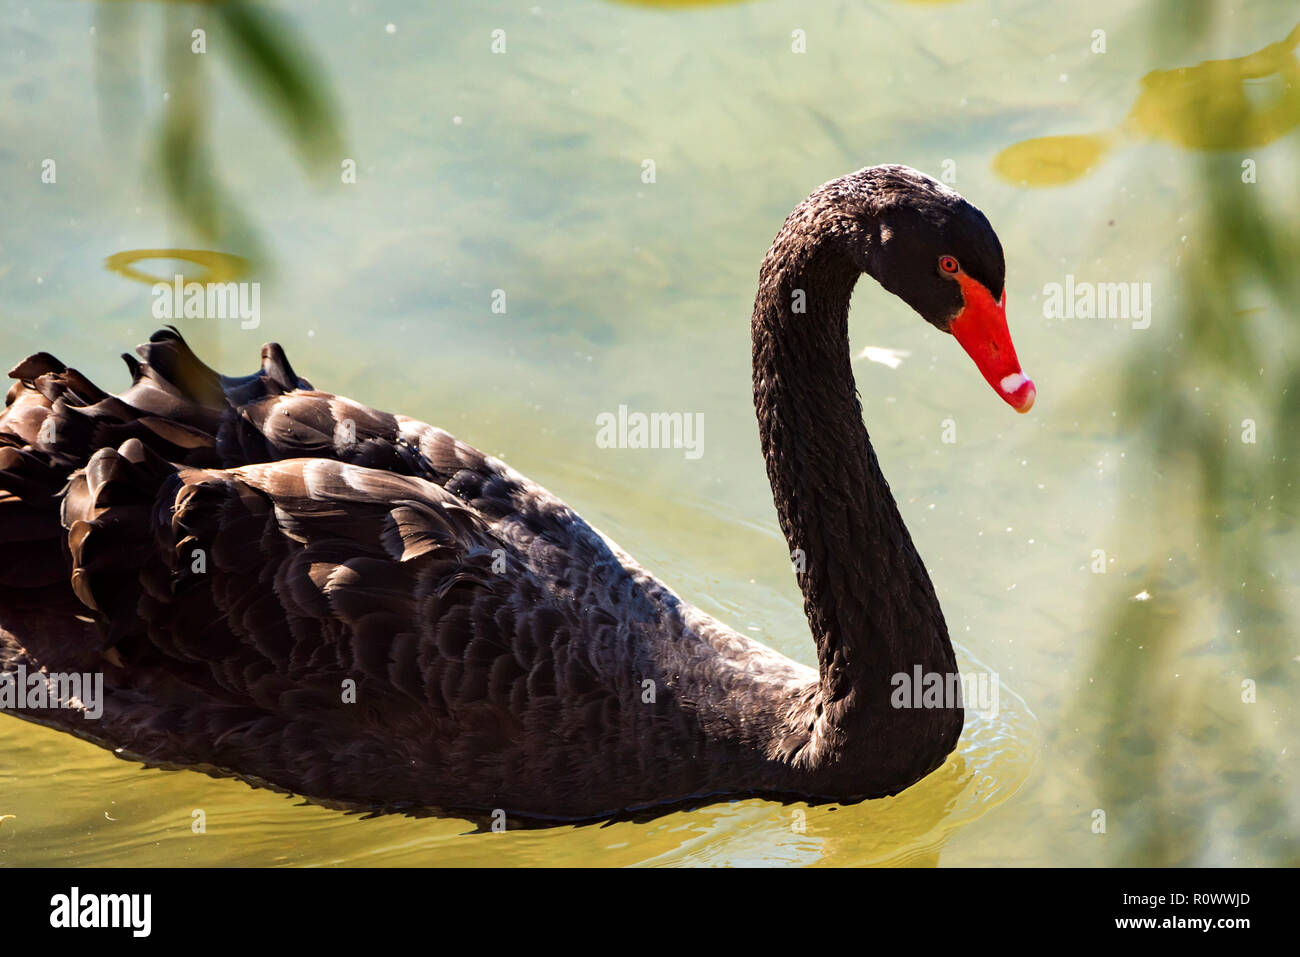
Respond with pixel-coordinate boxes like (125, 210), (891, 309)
(95, 0), (342, 265)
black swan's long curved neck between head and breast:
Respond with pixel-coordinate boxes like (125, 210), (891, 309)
(751, 204), (956, 723)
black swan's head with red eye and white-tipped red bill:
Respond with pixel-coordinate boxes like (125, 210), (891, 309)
(854, 166), (1036, 412)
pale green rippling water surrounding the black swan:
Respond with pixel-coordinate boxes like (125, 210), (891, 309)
(0, 0), (1300, 865)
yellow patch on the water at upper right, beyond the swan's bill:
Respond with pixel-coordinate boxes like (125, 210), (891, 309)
(993, 25), (1300, 186)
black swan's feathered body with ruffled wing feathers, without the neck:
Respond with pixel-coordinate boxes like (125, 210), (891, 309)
(0, 330), (818, 818)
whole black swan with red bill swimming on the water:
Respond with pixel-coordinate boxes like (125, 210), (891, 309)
(0, 166), (1035, 820)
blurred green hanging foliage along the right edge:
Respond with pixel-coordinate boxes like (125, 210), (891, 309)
(1075, 0), (1300, 866)
